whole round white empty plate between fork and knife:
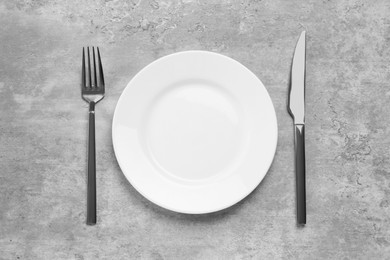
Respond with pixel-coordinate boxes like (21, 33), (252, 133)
(112, 51), (277, 214)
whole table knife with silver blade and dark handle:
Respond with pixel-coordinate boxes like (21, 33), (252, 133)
(288, 31), (306, 225)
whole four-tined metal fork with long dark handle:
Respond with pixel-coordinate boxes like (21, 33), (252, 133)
(81, 47), (105, 225)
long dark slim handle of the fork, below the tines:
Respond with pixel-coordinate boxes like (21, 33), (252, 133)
(87, 102), (96, 225)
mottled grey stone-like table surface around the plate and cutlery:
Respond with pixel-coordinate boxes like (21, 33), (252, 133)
(0, 0), (390, 259)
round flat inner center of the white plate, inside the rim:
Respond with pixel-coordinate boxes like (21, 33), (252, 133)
(144, 81), (242, 181)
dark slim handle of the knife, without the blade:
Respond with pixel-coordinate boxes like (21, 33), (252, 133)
(295, 125), (306, 225)
